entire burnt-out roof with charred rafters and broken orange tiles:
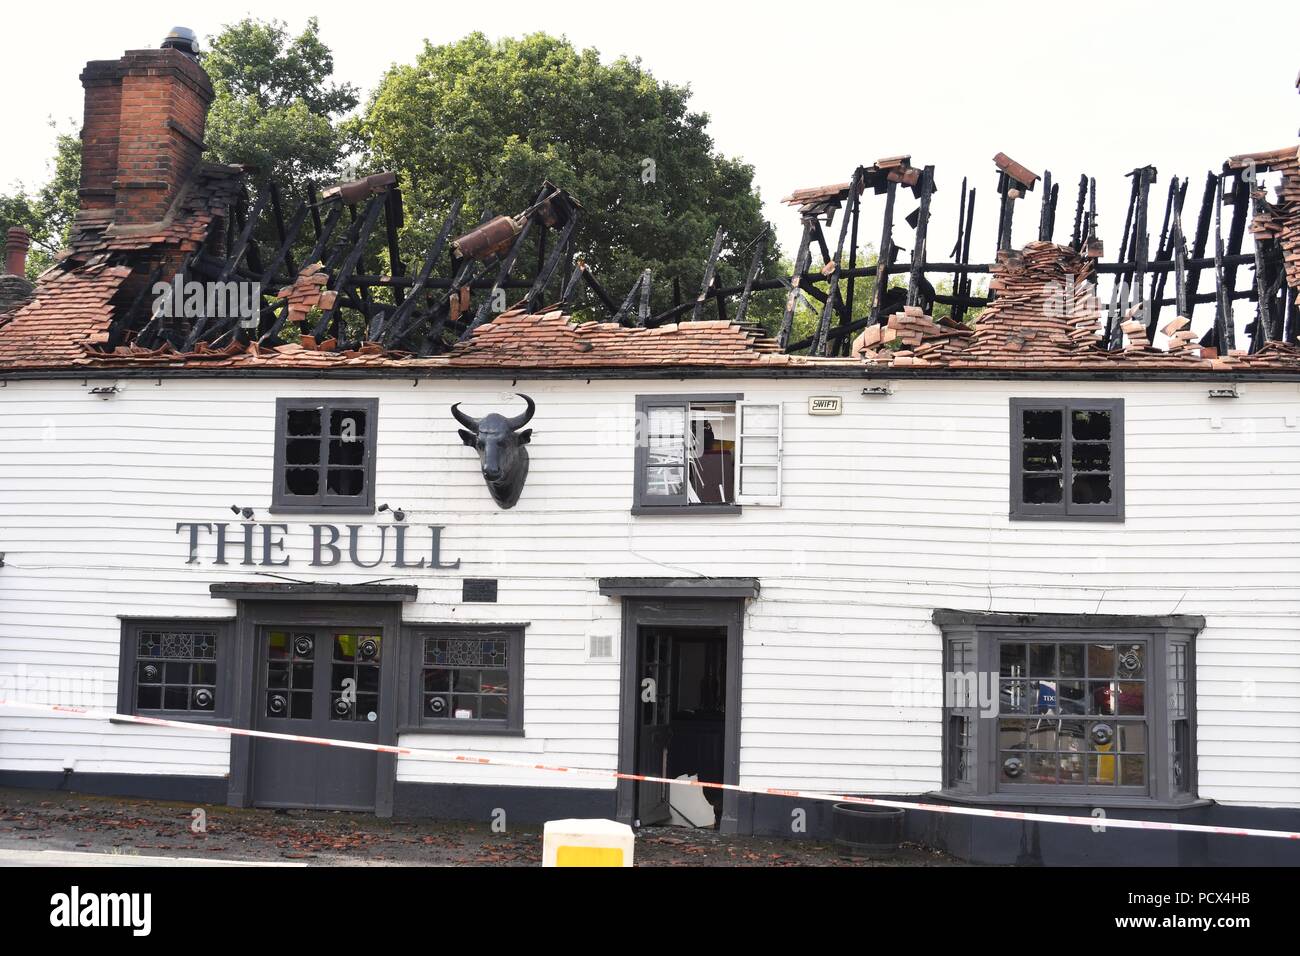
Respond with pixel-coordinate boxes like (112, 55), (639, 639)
(0, 41), (1300, 371)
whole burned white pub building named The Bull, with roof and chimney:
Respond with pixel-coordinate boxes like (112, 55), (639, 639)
(0, 31), (1300, 864)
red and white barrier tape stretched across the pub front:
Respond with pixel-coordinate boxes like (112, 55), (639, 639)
(0, 700), (1300, 840)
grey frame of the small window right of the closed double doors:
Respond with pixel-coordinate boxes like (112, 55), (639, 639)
(398, 622), (527, 737)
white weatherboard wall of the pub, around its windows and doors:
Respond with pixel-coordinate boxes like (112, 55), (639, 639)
(0, 378), (1300, 806)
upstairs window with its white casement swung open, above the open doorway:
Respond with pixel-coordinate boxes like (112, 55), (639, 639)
(633, 395), (781, 514)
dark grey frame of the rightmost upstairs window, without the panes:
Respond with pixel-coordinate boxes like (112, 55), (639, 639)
(1009, 398), (1125, 523)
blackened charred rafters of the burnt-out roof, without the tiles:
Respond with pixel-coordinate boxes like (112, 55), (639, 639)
(35, 150), (1300, 364)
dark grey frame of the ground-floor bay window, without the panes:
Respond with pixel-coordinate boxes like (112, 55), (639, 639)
(935, 610), (1205, 806)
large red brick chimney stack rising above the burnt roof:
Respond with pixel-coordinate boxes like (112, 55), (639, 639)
(79, 33), (213, 225)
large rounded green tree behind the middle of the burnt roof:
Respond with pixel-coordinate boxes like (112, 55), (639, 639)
(356, 34), (777, 321)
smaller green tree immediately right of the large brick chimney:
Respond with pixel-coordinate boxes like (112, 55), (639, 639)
(202, 17), (358, 186)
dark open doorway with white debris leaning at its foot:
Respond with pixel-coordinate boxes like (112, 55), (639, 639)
(633, 624), (727, 827)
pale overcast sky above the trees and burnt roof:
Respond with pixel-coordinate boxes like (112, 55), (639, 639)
(0, 0), (1300, 295)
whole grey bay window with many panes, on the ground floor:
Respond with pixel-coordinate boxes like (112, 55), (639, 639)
(935, 610), (1204, 804)
